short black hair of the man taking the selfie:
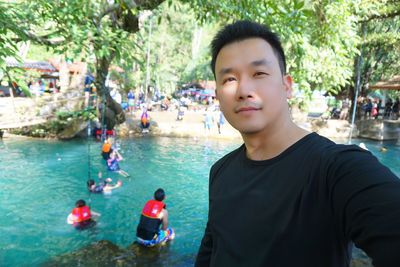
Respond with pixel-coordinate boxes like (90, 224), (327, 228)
(211, 20), (286, 77)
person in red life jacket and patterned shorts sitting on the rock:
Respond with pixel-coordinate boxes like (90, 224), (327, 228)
(136, 188), (175, 247)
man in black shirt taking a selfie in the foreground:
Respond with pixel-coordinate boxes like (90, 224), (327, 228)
(196, 21), (400, 267)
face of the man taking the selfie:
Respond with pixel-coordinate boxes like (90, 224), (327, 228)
(215, 38), (292, 134)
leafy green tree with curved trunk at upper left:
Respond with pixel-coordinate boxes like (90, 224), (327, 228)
(1, 0), (164, 129)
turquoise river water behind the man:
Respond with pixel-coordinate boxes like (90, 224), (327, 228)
(0, 138), (400, 266)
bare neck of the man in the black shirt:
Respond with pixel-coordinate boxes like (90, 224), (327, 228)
(242, 120), (310, 160)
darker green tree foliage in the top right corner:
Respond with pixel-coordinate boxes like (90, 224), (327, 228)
(350, 1), (400, 99)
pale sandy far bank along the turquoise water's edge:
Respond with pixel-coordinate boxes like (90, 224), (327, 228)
(0, 111), (350, 141)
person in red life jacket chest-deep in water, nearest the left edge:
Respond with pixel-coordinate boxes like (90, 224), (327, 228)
(67, 199), (100, 230)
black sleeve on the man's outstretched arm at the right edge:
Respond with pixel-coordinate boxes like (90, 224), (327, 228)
(326, 146), (400, 267)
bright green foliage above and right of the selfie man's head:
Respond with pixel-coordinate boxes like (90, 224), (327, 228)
(186, 0), (359, 101)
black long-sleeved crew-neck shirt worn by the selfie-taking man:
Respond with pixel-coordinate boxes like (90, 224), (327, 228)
(196, 133), (400, 267)
